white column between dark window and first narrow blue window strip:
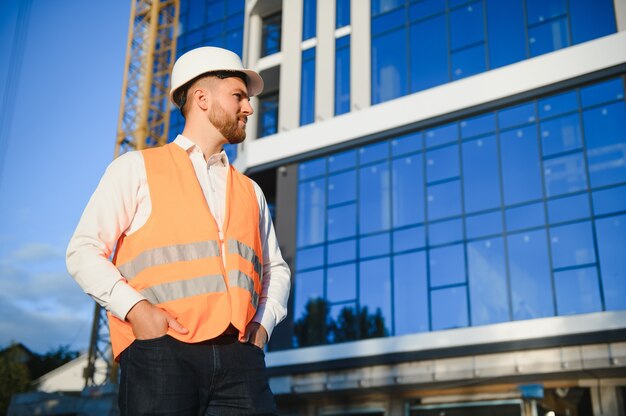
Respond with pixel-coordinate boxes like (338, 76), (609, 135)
(278, 0), (304, 132)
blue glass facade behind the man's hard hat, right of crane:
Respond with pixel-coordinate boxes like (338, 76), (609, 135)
(169, 0), (245, 161)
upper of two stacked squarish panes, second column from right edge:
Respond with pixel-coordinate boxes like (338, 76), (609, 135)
(540, 113), (582, 156)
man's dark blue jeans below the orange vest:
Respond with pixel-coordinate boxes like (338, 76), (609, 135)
(119, 335), (277, 416)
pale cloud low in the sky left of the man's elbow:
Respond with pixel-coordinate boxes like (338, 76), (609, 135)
(0, 249), (94, 353)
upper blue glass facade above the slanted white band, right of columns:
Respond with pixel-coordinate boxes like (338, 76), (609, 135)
(371, 0), (616, 104)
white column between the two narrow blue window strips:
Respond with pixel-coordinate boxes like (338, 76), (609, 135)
(315, 0), (336, 122)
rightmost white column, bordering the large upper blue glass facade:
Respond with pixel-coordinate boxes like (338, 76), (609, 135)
(350, 0), (372, 111)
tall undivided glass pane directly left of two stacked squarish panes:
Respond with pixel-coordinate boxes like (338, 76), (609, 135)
(500, 126), (542, 205)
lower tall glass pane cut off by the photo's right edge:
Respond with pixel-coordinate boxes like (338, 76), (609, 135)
(596, 215), (626, 311)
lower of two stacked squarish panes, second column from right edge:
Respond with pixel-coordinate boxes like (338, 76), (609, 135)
(543, 153), (587, 197)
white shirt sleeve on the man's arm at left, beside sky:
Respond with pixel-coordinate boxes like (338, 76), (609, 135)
(66, 152), (146, 320)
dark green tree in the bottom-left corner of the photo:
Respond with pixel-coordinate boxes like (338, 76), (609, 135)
(0, 344), (30, 414)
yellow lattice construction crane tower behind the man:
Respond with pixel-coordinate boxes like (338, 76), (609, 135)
(84, 0), (180, 387)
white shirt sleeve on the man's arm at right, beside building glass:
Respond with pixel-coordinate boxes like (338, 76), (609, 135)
(253, 181), (291, 337)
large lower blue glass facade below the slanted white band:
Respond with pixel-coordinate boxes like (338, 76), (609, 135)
(292, 76), (626, 346)
